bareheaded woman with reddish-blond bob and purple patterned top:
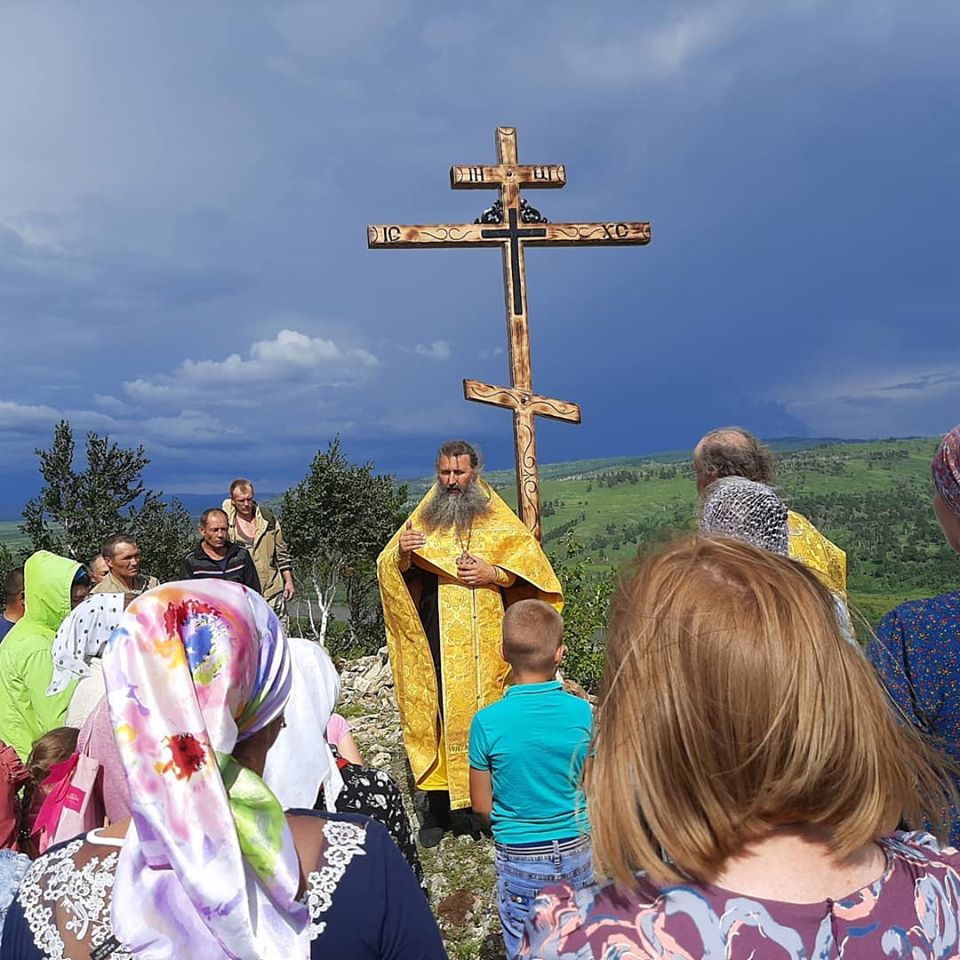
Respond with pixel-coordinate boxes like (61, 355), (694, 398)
(519, 537), (960, 960)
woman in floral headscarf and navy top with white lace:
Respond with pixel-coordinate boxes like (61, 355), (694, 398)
(0, 582), (446, 960)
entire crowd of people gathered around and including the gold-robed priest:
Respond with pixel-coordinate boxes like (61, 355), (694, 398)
(0, 427), (960, 960)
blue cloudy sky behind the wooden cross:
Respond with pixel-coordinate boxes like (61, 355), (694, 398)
(0, 0), (960, 516)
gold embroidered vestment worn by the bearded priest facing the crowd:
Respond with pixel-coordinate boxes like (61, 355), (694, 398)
(377, 480), (563, 809)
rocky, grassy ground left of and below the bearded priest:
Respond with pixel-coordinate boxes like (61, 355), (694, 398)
(338, 647), (504, 960)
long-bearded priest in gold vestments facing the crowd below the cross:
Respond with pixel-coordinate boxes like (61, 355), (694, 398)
(377, 440), (563, 846)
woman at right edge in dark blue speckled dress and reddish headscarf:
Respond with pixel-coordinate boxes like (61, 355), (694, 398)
(867, 426), (960, 846)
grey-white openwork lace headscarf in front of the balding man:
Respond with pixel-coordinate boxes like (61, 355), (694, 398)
(700, 477), (789, 557)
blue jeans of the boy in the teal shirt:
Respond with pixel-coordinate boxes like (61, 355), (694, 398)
(495, 837), (593, 960)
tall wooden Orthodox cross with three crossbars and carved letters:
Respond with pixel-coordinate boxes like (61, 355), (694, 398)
(367, 127), (650, 539)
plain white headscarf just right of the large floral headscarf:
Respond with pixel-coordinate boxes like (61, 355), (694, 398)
(263, 637), (343, 810)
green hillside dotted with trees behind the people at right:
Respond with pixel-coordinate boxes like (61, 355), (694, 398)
(410, 438), (960, 623)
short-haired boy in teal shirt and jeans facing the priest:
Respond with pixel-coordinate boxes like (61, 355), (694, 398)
(470, 600), (593, 960)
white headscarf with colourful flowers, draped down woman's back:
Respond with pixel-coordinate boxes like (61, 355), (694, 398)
(103, 580), (308, 960)
